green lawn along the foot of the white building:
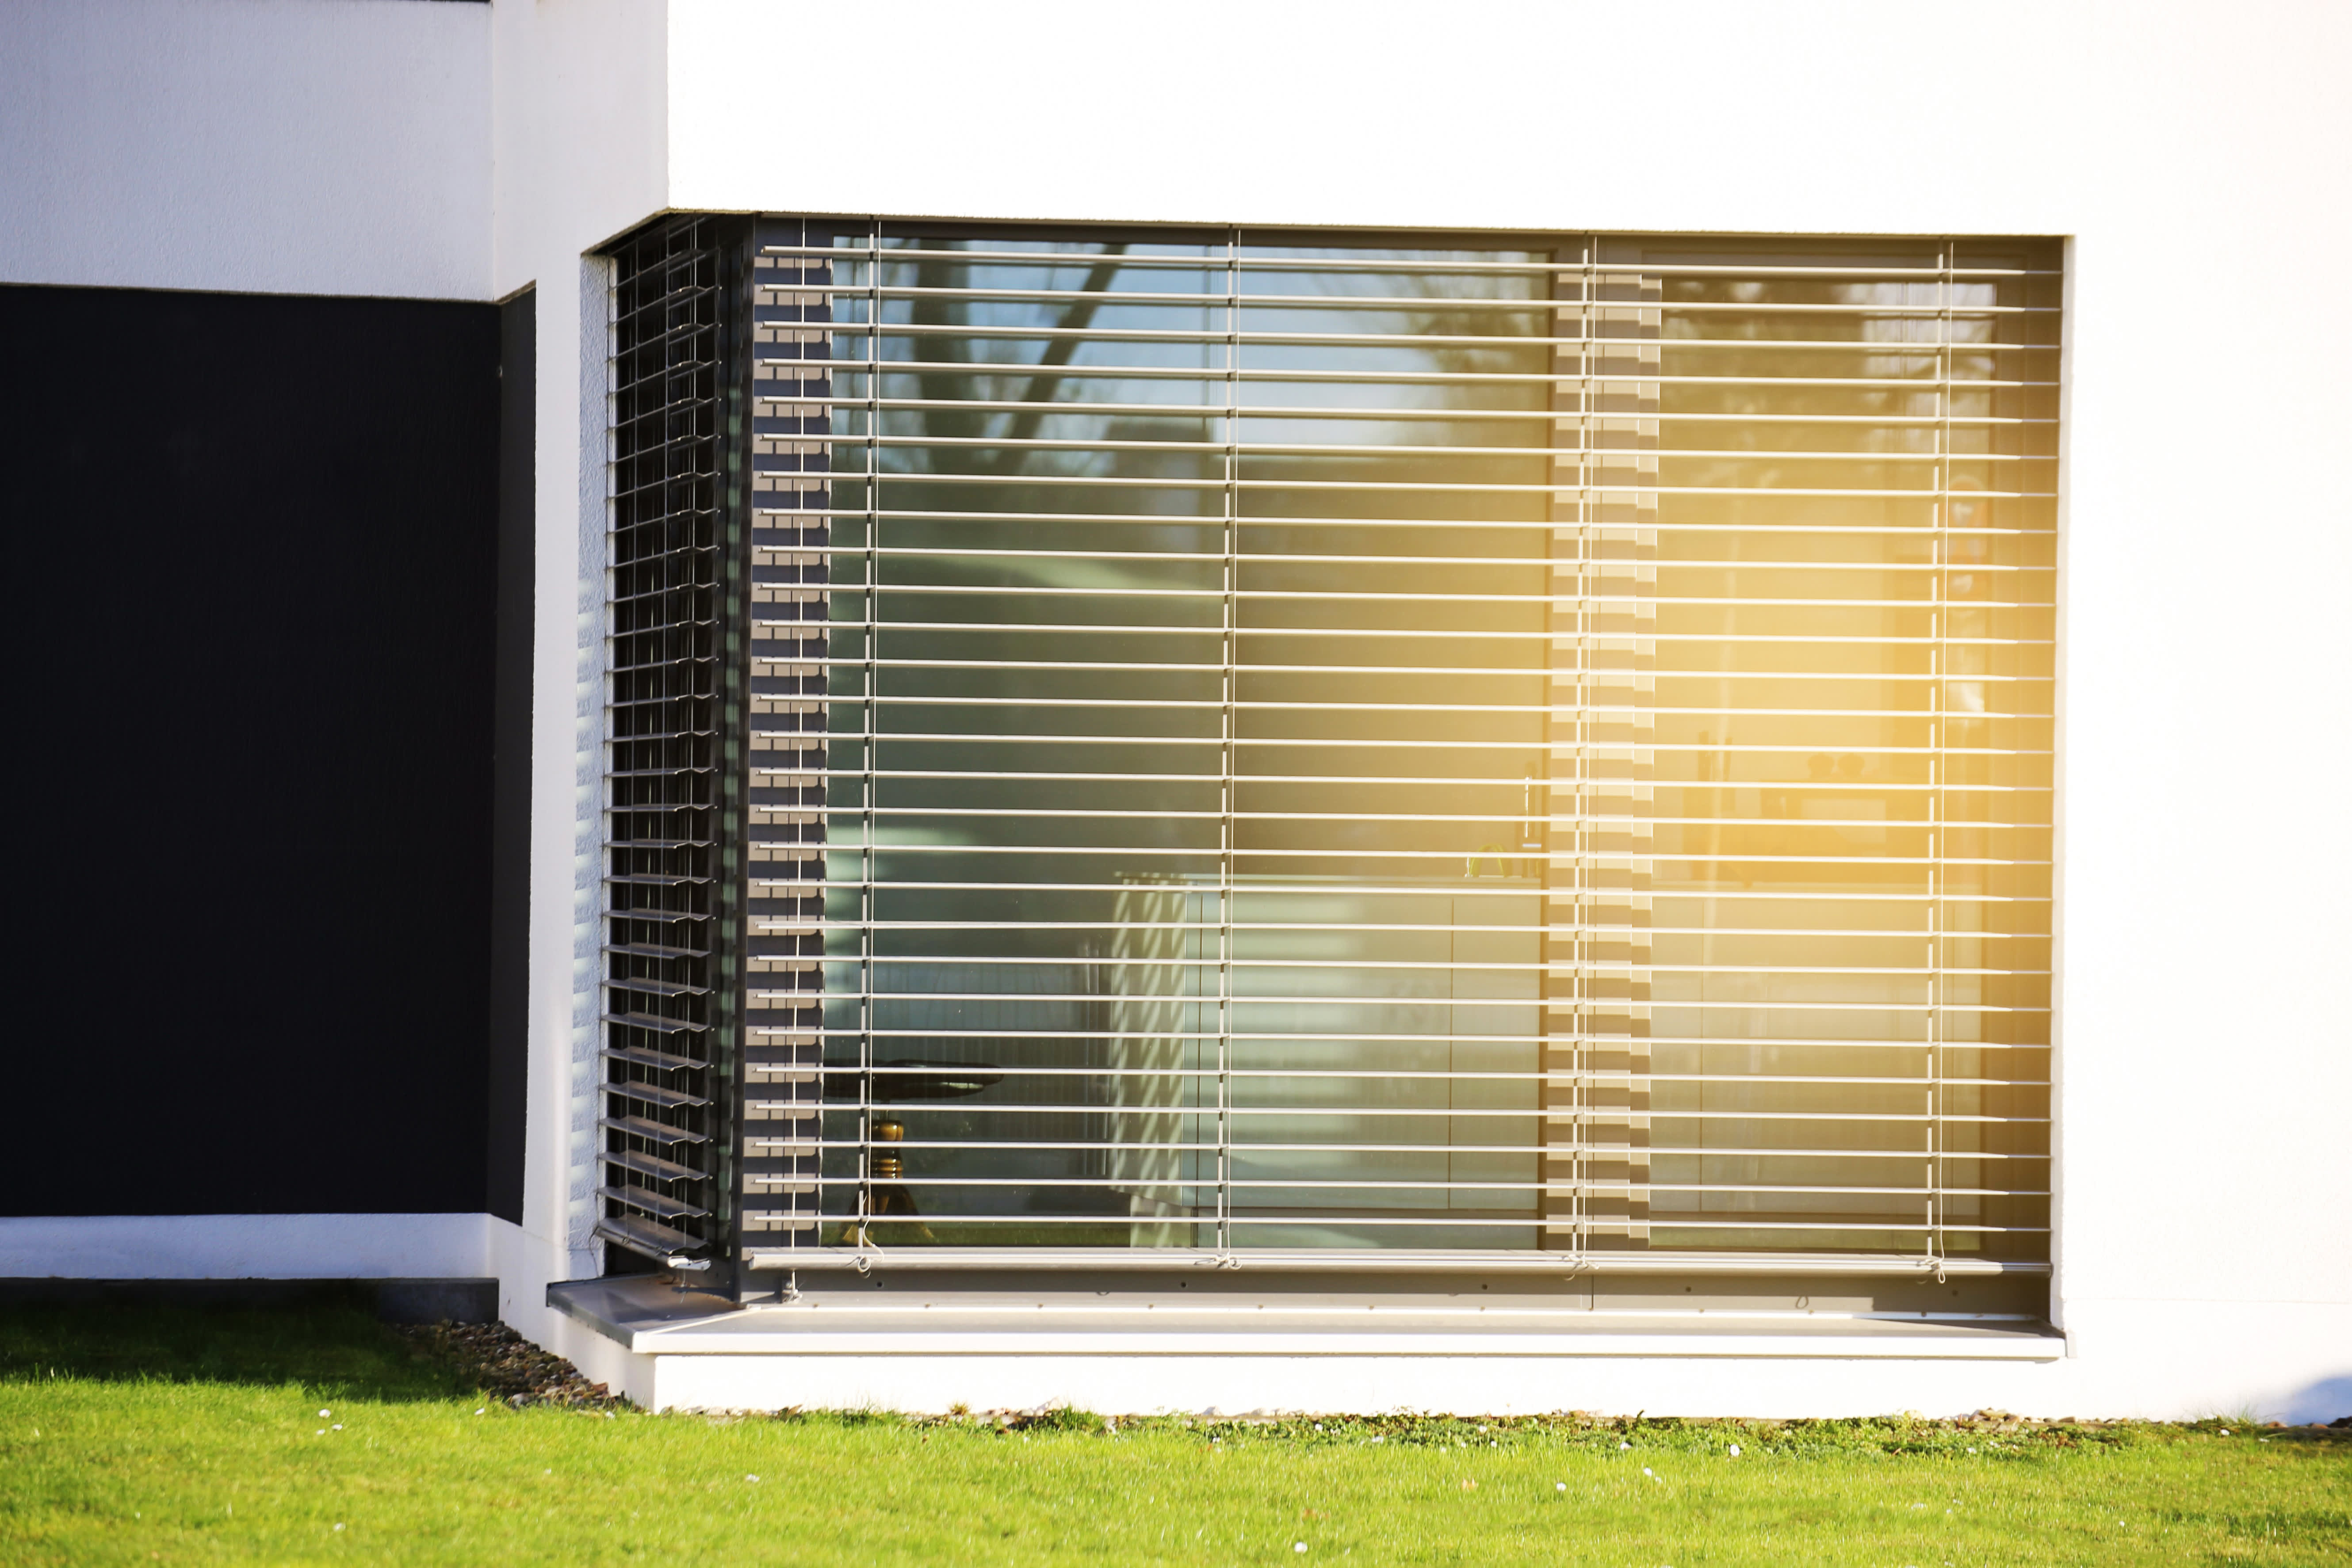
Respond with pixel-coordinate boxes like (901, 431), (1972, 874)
(0, 1300), (2352, 1568)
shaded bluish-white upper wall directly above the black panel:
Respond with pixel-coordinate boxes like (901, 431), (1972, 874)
(0, 0), (489, 298)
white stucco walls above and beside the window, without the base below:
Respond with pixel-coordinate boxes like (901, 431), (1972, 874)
(0, 0), (2352, 1413)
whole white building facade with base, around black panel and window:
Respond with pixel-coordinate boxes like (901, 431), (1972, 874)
(0, 0), (2352, 1420)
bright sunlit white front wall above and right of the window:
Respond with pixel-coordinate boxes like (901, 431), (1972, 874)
(644, 0), (2352, 1411)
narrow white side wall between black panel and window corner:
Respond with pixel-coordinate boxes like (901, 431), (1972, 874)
(492, 0), (668, 1347)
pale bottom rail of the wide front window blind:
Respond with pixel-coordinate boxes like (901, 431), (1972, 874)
(743, 1246), (2051, 1279)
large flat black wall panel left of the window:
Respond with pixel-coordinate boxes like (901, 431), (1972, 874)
(0, 287), (515, 1215)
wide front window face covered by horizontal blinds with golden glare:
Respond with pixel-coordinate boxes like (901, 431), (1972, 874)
(614, 219), (2060, 1288)
